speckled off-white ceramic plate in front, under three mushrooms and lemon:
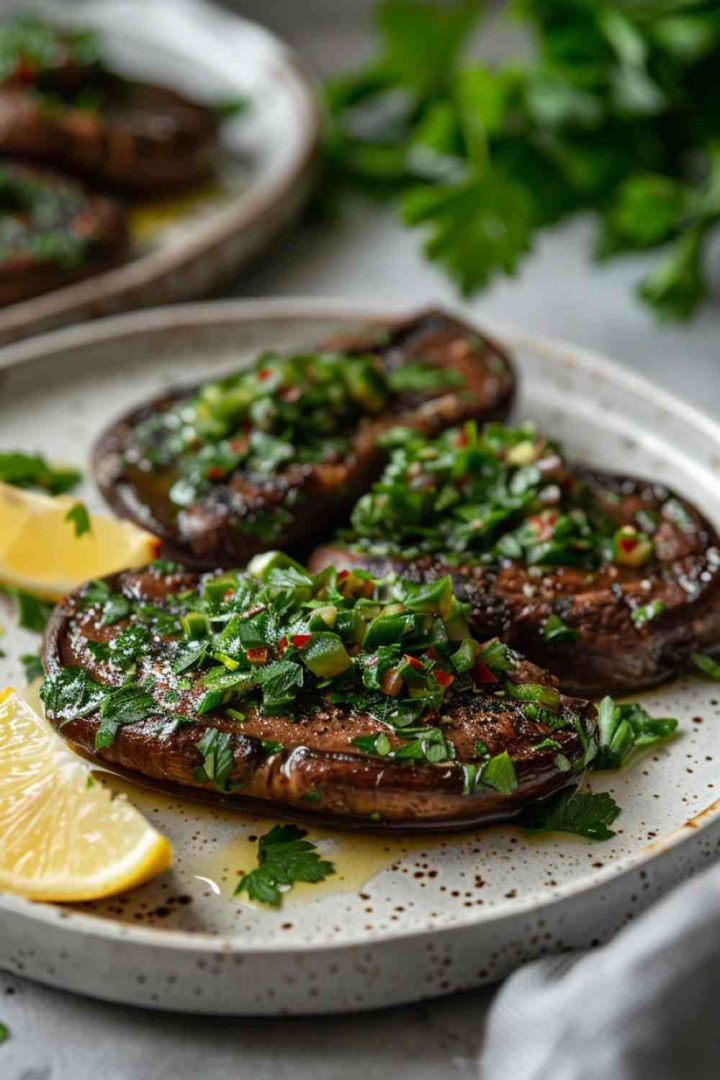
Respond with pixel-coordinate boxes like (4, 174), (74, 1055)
(0, 300), (720, 1014)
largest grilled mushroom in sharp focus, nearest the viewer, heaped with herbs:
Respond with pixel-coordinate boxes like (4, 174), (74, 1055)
(41, 553), (596, 827)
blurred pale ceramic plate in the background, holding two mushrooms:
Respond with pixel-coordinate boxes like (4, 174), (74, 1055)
(0, 0), (321, 345)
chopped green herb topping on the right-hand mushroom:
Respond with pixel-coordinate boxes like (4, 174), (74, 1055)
(340, 422), (654, 574)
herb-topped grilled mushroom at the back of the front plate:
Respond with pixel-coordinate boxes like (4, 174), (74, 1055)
(94, 311), (515, 569)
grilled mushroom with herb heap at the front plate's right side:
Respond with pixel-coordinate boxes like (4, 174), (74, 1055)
(310, 416), (720, 697)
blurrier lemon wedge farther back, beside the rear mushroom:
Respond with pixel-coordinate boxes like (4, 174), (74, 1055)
(0, 483), (159, 600)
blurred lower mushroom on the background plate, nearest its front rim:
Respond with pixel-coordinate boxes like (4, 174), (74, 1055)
(0, 162), (127, 305)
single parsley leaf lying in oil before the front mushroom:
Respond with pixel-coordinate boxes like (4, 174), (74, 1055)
(235, 825), (335, 907)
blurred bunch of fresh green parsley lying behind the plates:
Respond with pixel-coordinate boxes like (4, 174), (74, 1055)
(325, 0), (720, 319)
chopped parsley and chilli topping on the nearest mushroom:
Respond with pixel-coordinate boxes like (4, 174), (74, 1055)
(42, 552), (593, 795)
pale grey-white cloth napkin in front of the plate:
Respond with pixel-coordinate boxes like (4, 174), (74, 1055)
(480, 865), (720, 1080)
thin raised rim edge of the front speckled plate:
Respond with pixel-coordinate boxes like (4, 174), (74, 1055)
(0, 297), (720, 956)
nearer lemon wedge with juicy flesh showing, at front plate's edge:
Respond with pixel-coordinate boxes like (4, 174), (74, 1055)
(0, 689), (173, 902)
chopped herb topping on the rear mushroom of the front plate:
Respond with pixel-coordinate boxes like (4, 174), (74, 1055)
(125, 352), (462, 511)
